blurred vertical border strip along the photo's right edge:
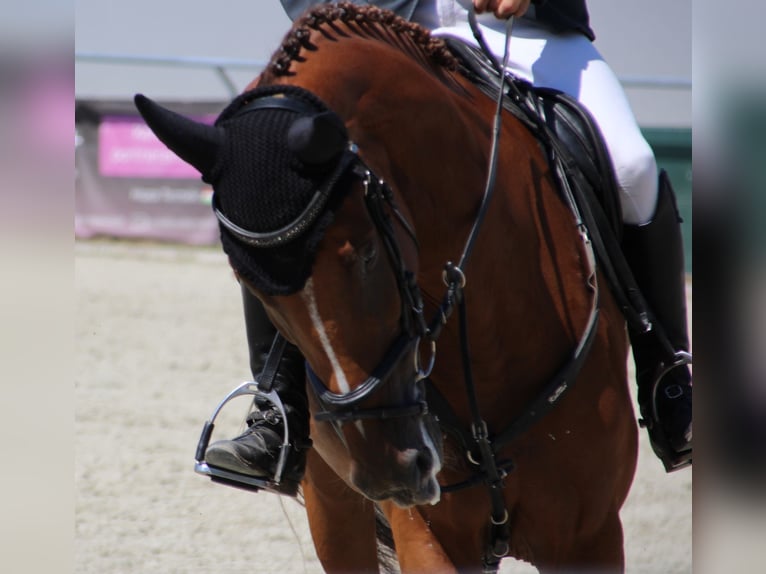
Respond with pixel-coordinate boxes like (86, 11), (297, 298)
(692, 0), (766, 572)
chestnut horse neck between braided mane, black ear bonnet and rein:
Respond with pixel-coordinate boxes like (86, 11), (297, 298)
(272, 27), (489, 258)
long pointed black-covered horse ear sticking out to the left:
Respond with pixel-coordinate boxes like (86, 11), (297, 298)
(133, 94), (224, 181)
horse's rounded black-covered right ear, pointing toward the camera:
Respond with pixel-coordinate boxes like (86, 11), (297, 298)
(287, 112), (348, 165)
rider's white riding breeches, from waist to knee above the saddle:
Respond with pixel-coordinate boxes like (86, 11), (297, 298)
(434, 9), (657, 224)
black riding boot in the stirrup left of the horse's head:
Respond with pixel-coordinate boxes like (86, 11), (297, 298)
(205, 285), (311, 495)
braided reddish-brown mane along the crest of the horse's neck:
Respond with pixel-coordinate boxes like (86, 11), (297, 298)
(265, 2), (458, 77)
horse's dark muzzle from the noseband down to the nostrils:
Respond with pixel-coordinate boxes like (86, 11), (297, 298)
(306, 334), (442, 507)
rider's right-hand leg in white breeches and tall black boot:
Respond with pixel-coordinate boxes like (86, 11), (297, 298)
(488, 23), (692, 470)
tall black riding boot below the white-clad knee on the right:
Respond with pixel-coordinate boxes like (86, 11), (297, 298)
(623, 171), (692, 472)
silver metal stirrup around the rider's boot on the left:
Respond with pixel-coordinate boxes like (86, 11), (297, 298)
(194, 381), (298, 496)
